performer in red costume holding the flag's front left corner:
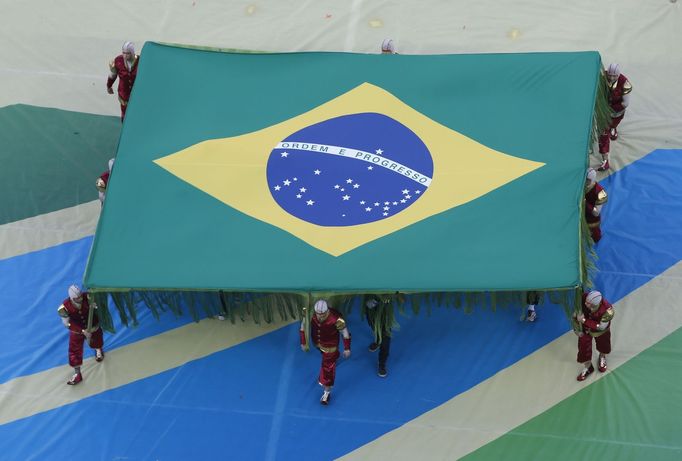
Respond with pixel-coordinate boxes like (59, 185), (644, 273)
(57, 285), (104, 386)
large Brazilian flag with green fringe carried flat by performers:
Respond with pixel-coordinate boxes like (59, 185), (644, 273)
(85, 43), (601, 328)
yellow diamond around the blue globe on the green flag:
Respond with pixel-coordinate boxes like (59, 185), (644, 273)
(155, 83), (544, 256)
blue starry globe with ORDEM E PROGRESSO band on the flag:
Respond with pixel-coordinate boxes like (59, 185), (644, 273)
(266, 113), (433, 227)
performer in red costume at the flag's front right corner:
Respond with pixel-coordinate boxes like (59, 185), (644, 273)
(575, 291), (614, 381)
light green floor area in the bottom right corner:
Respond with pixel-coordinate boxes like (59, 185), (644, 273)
(462, 328), (682, 461)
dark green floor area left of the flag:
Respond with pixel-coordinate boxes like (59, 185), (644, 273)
(0, 104), (121, 224)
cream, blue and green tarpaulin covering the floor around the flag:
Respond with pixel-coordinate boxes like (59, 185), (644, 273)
(0, 0), (682, 460)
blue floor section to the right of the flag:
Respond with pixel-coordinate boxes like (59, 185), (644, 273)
(596, 149), (682, 307)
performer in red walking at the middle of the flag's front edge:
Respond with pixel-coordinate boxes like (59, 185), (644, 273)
(300, 299), (350, 405)
